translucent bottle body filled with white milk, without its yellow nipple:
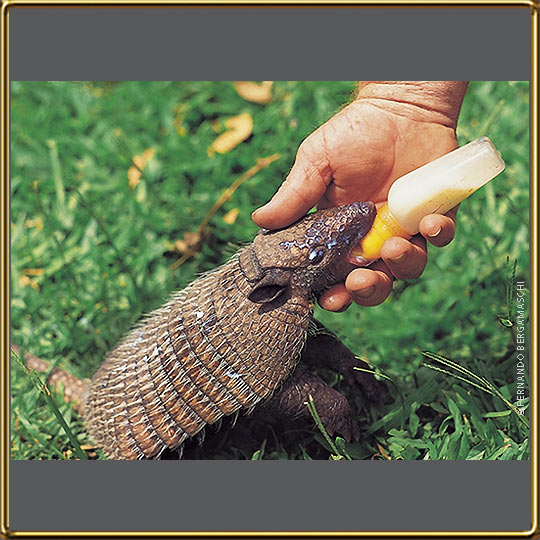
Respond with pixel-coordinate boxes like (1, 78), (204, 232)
(388, 137), (504, 235)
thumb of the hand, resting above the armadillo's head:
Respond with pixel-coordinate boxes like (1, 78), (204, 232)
(251, 132), (333, 229)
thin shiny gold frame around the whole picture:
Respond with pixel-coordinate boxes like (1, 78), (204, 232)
(0, 0), (540, 538)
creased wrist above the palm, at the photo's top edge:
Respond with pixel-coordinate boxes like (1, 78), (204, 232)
(356, 81), (468, 129)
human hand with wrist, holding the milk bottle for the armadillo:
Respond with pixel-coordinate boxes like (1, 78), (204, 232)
(253, 81), (467, 311)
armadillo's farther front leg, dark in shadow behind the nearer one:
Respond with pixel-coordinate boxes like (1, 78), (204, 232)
(302, 320), (381, 401)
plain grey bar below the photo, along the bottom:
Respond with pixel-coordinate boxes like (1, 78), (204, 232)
(10, 461), (531, 531)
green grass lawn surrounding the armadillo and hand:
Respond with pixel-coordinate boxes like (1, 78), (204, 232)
(11, 82), (529, 459)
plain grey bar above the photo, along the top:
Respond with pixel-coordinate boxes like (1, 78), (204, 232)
(10, 7), (530, 80)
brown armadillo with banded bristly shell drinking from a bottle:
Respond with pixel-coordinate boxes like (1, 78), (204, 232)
(25, 202), (376, 459)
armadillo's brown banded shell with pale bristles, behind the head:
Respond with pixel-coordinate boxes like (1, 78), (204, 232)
(83, 253), (310, 459)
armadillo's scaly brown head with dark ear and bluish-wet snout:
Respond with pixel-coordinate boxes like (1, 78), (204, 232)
(248, 202), (376, 303)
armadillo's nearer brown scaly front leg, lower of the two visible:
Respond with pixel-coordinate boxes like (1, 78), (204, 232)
(265, 368), (359, 441)
